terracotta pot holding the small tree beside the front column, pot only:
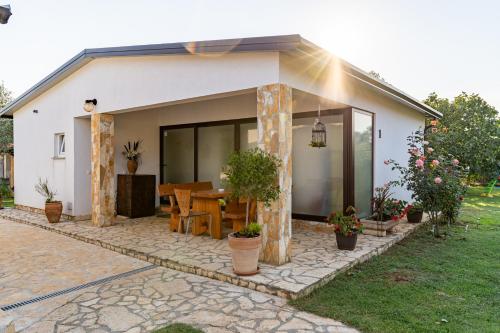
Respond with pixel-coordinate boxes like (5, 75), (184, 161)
(228, 233), (262, 275)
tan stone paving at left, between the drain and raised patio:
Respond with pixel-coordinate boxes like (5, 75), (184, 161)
(0, 221), (148, 306)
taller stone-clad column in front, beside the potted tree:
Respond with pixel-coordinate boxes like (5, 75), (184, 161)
(257, 84), (292, 265)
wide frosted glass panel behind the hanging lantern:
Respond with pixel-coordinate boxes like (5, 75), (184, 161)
(292, 115), (343, 216)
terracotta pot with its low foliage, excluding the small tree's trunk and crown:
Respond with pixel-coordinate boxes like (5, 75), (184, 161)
(228, 222), (262, 275)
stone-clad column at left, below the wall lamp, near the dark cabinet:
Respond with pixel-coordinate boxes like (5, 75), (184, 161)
(91, 113), (115, 227)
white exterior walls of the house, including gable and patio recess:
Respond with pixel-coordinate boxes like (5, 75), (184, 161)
(14, 48), (424, 216)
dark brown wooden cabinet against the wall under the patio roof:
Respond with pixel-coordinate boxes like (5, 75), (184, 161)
(116, 175), (156, 218)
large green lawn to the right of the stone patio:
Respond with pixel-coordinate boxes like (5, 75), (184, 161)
(291, 188), (500, 333)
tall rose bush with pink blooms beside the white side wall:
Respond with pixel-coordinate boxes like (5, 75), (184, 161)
(389, 126), (466, 236)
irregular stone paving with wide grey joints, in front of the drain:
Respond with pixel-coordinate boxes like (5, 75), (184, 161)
(16, 267), (357, 333)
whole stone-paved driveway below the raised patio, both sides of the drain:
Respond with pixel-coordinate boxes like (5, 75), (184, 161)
(0, 219), (357, 333)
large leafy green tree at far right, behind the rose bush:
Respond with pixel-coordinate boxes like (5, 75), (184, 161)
(424, 92), (500, 180)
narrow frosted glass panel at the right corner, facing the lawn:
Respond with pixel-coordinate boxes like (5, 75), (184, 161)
(353, 112), (373, 217)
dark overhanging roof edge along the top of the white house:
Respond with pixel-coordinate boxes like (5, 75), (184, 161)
(0, 35), (441, 117)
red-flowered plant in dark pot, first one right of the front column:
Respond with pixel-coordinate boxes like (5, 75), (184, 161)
(328, 206), (364, 251)
